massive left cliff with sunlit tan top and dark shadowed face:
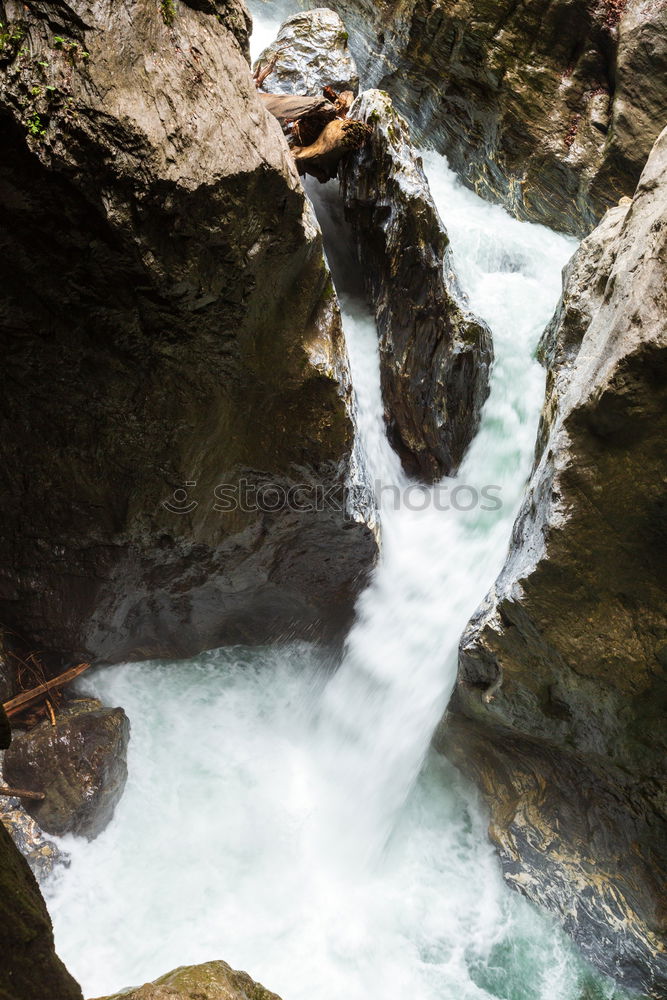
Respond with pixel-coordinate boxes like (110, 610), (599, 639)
(0, 0), (375, 662)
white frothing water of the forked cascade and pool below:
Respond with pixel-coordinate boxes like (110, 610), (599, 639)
(41, 9), (628, 1000)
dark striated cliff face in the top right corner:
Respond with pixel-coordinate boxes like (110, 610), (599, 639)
(304, 0), (667, 235)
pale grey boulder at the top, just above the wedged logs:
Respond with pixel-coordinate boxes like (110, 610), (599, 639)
(255, 7), (359, 97)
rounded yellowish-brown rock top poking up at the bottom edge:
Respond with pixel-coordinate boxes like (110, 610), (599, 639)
(92, 962), (280, 1000)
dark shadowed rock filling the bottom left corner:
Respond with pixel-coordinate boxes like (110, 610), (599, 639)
(0, 708), (82, 1000)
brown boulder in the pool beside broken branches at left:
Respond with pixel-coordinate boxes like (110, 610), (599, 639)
(3, 699), (130, 840)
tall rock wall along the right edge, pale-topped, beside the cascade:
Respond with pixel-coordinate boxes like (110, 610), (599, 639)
(438, 130), (667, 998)
